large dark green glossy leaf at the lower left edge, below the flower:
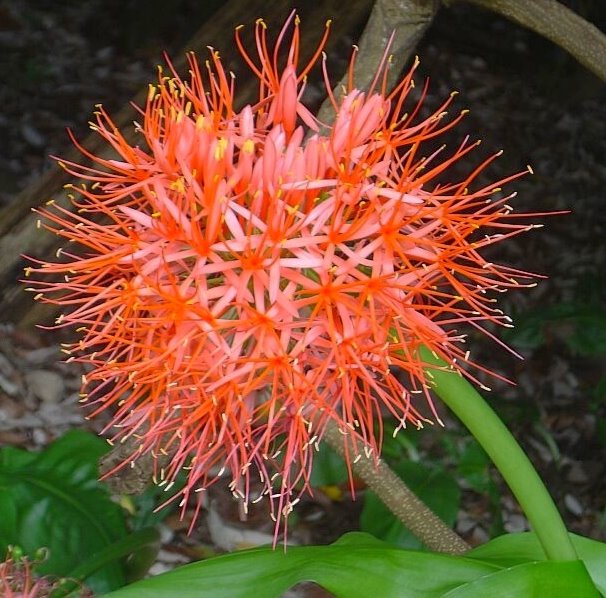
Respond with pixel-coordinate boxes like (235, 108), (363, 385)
(0, 430), (126, 592)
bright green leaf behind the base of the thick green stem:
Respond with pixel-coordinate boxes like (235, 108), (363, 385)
(467, 532), (606, 596)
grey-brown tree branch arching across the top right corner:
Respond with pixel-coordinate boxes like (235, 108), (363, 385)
(443, 0), (606, 81)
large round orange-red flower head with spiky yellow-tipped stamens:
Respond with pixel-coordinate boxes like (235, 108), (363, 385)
(27, 17), (532, 536)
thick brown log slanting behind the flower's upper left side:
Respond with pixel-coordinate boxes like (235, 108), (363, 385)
(0, 0), (372, 327)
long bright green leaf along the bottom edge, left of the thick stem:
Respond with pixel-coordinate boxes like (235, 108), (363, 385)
(107, 534), (500, 598)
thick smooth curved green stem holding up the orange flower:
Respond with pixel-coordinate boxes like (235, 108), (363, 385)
(420, 347), (578, 561)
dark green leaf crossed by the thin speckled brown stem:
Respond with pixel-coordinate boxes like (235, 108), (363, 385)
(360, 462), (461, 548)
